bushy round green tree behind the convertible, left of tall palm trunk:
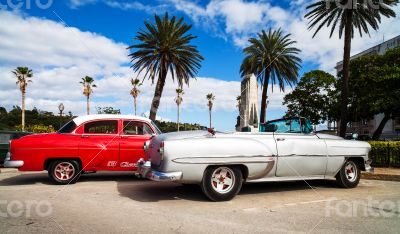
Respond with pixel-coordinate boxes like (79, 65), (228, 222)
(283, 70), (336, 125)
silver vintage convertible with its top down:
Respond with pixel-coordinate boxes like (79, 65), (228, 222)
(137, 118), (373, 201)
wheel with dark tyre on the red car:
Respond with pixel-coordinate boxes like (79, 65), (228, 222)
(48, 159), (81, 185)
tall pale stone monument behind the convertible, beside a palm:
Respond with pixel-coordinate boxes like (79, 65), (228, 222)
(236, 74), (259, 132)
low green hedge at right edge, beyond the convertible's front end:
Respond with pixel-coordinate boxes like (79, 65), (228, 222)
(368, 141), (400, 167)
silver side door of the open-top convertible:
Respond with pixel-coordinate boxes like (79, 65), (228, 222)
(274, 121), (327, 177)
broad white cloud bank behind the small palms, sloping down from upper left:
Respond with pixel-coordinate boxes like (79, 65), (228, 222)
(0, 11), (294, 124)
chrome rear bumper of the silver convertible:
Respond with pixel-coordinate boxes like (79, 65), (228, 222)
(135, 159), (182, 181)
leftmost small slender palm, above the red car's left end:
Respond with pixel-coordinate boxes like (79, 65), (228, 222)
(12, 67), (33, 131)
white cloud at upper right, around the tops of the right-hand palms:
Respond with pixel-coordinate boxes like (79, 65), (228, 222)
(169, 0), (400, 73)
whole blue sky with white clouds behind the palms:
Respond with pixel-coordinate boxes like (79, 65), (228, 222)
(0, 0), (400, 130)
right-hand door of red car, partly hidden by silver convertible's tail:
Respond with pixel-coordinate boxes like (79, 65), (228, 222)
(119, 120), (154, 170)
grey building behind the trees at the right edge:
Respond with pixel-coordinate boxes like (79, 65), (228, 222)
(336, 35), (400, 139)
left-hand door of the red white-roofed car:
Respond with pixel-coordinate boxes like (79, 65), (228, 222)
(79, 120), (119, 171)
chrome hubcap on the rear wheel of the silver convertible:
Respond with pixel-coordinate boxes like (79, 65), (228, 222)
(211, 167), (235, 193)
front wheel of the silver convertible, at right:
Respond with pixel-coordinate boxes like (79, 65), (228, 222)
(336, 159), (361, 188)
